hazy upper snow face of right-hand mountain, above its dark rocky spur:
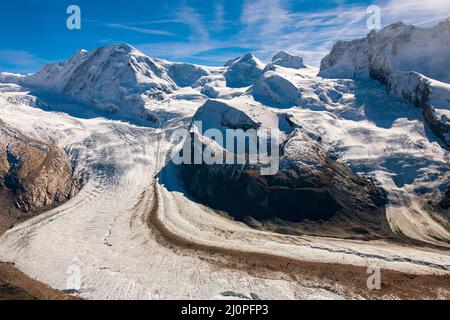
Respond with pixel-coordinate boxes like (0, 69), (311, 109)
(320, 18), (450, 83)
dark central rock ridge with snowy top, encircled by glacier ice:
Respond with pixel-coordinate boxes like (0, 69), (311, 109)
(180, 100), (389, 237)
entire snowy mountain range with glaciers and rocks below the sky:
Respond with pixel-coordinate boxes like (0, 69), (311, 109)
(0, 18), (450, 298)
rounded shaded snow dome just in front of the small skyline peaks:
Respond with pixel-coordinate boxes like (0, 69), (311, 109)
(252, 71), (300, 107)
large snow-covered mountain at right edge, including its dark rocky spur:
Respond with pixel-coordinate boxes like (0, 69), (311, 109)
(319, 18), (450, 145)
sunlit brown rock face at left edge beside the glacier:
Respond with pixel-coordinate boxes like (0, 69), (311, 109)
(0, 121), (80, 212)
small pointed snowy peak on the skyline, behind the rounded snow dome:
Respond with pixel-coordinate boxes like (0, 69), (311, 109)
(225, 53), (265, 88)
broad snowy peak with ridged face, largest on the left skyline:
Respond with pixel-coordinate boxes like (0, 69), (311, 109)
(26, 45), (176, 117)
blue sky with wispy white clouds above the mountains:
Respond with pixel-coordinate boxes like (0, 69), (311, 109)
(0, 0), (450, 73)
